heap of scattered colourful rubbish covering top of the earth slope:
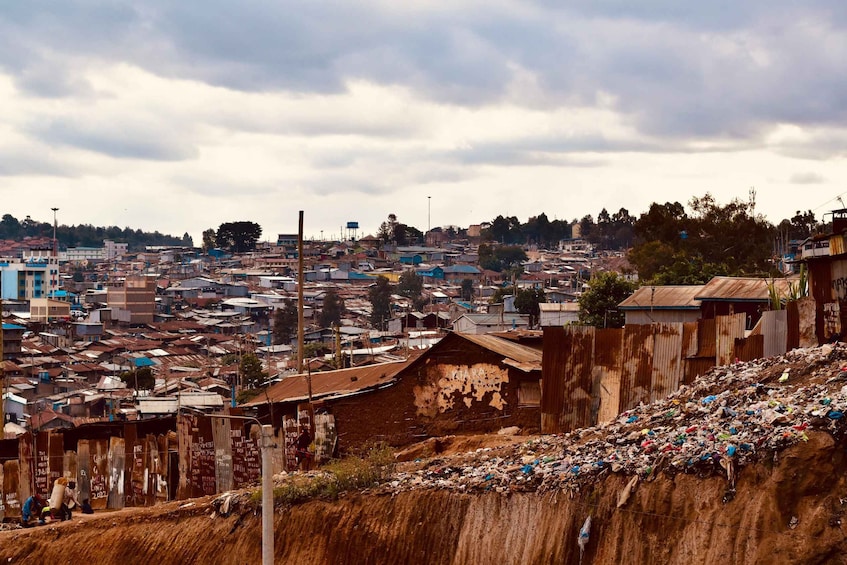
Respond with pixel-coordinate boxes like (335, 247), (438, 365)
(383, 343), (847, 493)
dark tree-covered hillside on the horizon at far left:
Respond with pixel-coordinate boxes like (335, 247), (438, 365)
(0, 214), (194, 251)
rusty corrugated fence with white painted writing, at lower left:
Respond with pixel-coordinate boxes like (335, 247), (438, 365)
(0, 414), (336, 519)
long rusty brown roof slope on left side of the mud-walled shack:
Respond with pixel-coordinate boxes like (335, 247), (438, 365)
(243, 357), (416, 407)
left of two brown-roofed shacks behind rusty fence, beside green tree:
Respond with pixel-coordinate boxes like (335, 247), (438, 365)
(616, 285), (714, 326)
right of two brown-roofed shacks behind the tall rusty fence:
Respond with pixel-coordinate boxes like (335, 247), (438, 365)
(694, 277), (790, 330)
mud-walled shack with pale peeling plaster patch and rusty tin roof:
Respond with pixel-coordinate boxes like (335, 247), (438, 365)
(244, 333), (541, 451)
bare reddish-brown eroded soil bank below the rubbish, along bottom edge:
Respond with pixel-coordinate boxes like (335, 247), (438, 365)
(0, 433), (847, 565)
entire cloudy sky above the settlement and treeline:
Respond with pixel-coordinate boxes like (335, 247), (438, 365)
(0, 0), (847, 243)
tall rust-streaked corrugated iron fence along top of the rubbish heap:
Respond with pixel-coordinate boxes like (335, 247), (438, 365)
(541, 310), (800, 433)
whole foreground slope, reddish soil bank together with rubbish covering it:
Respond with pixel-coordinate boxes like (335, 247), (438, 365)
(0, 344), (847, 565)
